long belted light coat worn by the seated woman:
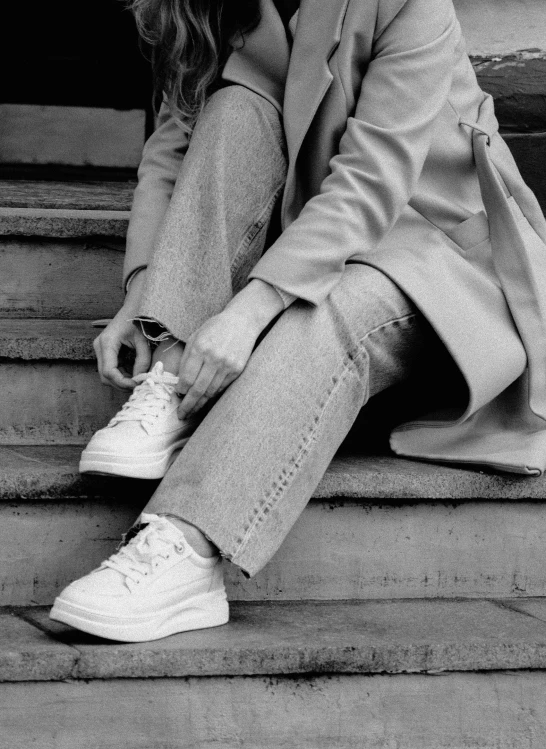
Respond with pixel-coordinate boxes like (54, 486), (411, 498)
(125, 0), (546, 474)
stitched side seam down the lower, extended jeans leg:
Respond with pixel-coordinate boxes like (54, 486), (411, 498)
(231, 312), (417, 559)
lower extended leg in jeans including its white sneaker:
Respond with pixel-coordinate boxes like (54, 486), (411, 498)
(51, 265), (442, 641)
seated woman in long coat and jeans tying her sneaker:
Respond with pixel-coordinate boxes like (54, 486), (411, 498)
(52, 0), (546, 641)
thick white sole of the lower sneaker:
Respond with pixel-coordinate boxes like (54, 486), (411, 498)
(50, 590), (229, 642)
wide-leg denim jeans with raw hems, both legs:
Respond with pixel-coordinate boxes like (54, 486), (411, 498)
(139, 86), (439, 575)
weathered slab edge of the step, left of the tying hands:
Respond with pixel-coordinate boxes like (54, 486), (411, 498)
(0, 319), (99, 361)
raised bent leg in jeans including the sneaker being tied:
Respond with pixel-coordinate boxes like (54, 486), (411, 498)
(80, 86), (286, 480)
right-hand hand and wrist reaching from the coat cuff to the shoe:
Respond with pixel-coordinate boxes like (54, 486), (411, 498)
(177, 279), (284, 419)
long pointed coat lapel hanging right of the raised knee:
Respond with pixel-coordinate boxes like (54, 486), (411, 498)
(284, 0), (349, 165)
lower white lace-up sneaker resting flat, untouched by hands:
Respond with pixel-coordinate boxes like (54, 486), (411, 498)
(50, 513), (229, 642)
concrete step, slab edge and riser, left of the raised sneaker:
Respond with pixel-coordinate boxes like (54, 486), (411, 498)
(0, 319), (127, 444)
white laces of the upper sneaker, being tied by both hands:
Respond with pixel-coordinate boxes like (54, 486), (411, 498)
(108, 372), (178, 426)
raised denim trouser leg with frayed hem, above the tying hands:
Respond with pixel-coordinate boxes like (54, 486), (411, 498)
(140, 86), (286, 341)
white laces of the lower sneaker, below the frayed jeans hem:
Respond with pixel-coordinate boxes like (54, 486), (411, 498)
(102, 524), (185, 584)
